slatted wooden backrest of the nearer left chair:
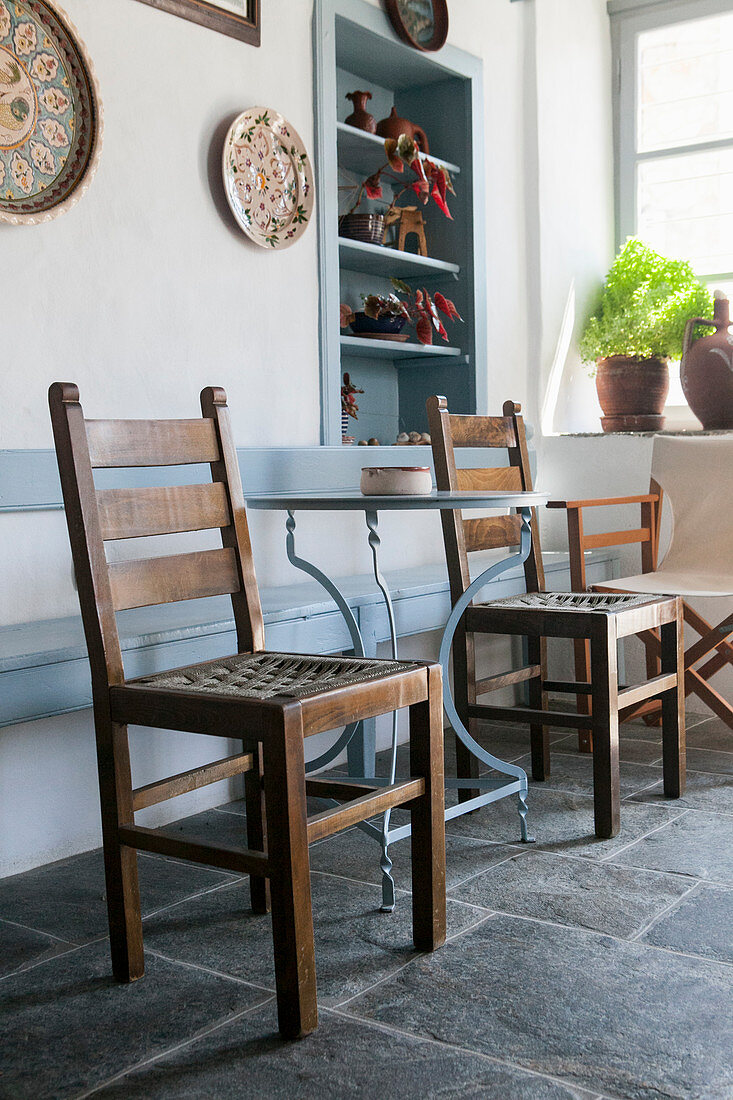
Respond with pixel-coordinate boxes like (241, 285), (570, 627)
(48, 382), (264, 692)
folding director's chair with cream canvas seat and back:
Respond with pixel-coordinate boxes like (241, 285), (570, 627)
(548, 436), (733, 749)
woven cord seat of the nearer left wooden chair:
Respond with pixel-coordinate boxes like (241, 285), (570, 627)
(134, 653), (419, 699)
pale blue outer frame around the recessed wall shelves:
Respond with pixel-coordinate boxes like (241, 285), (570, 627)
(313, 0), (489, 446)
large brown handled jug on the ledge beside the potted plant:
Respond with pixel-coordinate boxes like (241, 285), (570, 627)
(680, 297), (733, 431)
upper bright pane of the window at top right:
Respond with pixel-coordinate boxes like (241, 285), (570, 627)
(637, 12), (733, 153)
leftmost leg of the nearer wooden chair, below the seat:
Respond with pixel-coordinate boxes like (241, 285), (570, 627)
(96, 718), (145, 981)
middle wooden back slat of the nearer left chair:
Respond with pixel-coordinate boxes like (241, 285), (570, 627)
(97, 482), (231, 539)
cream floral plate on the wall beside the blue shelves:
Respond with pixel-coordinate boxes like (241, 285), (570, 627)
(223, 107), (314, 249)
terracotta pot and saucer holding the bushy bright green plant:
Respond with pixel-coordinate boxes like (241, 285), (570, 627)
(595, 355), (669, 431)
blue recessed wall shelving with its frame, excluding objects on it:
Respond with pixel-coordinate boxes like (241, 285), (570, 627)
(313, 0), (489, 446)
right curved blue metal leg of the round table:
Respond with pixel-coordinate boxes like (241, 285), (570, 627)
(438, 508), (534, 842)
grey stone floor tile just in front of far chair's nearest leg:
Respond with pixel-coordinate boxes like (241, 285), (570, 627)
(450, 851), (689, 937)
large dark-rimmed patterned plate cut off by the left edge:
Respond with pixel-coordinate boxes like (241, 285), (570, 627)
(0, 0), (101, 224)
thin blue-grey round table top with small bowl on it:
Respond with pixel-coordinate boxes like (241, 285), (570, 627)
(244, 488), (549, 512)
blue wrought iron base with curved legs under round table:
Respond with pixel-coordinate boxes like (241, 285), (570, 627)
(285, 508), (534, 913)
